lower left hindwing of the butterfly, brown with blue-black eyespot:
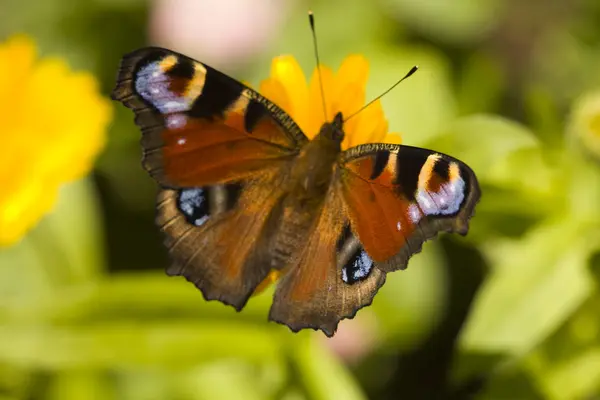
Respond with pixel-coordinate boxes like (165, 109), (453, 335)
(157, 170), (290, 310)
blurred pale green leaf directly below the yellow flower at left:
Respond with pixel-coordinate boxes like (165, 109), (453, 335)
(0, 179), (103, 318)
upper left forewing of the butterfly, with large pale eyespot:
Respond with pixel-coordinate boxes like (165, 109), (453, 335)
(112, 47), (307, 188)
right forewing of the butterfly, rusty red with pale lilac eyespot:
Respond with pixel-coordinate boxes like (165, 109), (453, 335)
(340, 144), (480, 272)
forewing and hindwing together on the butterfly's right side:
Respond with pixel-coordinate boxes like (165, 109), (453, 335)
(270, 144), (480, 336)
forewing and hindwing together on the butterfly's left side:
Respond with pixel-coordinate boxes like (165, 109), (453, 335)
(112, 48), (308, 310)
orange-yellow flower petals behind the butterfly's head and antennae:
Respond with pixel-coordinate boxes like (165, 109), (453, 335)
(260, 55), (402, 149)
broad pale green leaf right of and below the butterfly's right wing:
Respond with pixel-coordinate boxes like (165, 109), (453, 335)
(460, 218), (593, 356)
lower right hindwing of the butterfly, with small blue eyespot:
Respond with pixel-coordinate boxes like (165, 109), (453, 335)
(269, 185), (385, 337)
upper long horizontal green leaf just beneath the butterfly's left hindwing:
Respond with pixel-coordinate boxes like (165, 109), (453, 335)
(0, 272), (279, 327)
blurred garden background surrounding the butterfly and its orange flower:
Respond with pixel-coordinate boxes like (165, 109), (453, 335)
(0, 0), (600, 400)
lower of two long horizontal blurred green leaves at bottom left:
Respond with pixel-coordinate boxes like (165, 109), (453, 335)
(0, 319), (282, 369)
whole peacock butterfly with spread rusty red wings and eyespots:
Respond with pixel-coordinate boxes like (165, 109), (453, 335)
(112, 47), (480, 337)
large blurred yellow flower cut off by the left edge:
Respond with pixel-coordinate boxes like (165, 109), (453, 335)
(0, 35), (112, 246)
